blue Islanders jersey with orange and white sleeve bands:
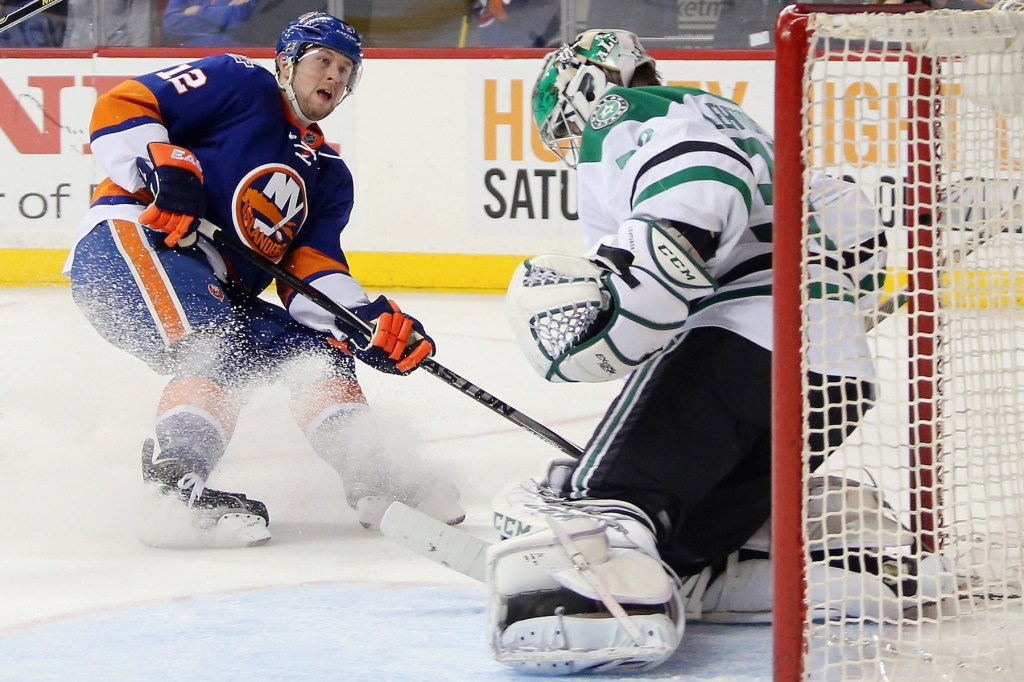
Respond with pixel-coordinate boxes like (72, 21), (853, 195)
(65, 54), (369, 331)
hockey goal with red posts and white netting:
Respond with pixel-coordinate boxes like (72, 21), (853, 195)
(772, 5), (1024, 682)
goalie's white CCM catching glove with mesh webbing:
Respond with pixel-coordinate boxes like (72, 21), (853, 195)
(506, 218), (717, 382)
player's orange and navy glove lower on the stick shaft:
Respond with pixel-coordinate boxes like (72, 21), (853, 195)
(338, 296), (434, 376)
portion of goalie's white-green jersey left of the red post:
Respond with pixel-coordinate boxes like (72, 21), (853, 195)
(579, 87), (773, 349)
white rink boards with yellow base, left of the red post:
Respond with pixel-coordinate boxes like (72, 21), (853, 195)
(0, 49), (774, 291)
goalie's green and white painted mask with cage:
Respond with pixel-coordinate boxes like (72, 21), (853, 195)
(532, 29), (654, 168)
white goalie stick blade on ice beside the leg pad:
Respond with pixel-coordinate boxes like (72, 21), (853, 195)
(381, 502), (490, 583)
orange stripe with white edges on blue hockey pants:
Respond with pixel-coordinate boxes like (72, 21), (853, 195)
(110, 220), (191, 346)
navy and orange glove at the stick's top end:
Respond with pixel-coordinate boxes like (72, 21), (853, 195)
(135, 142), (206, 247)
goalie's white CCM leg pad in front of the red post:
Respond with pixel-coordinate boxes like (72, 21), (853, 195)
(486, 511), (684, 675)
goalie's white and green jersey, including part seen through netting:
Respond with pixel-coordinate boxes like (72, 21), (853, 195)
(579, 87), (886, 380)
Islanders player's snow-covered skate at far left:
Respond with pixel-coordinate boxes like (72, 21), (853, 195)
(142, 439), (270, 548)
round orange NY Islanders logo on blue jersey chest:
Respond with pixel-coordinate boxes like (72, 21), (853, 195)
(231, 164), (308, 262)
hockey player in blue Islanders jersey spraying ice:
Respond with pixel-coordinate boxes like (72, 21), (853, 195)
(66, 12), (463, 545)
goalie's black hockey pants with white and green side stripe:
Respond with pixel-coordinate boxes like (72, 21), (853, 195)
(571, 328), (873, 576)
